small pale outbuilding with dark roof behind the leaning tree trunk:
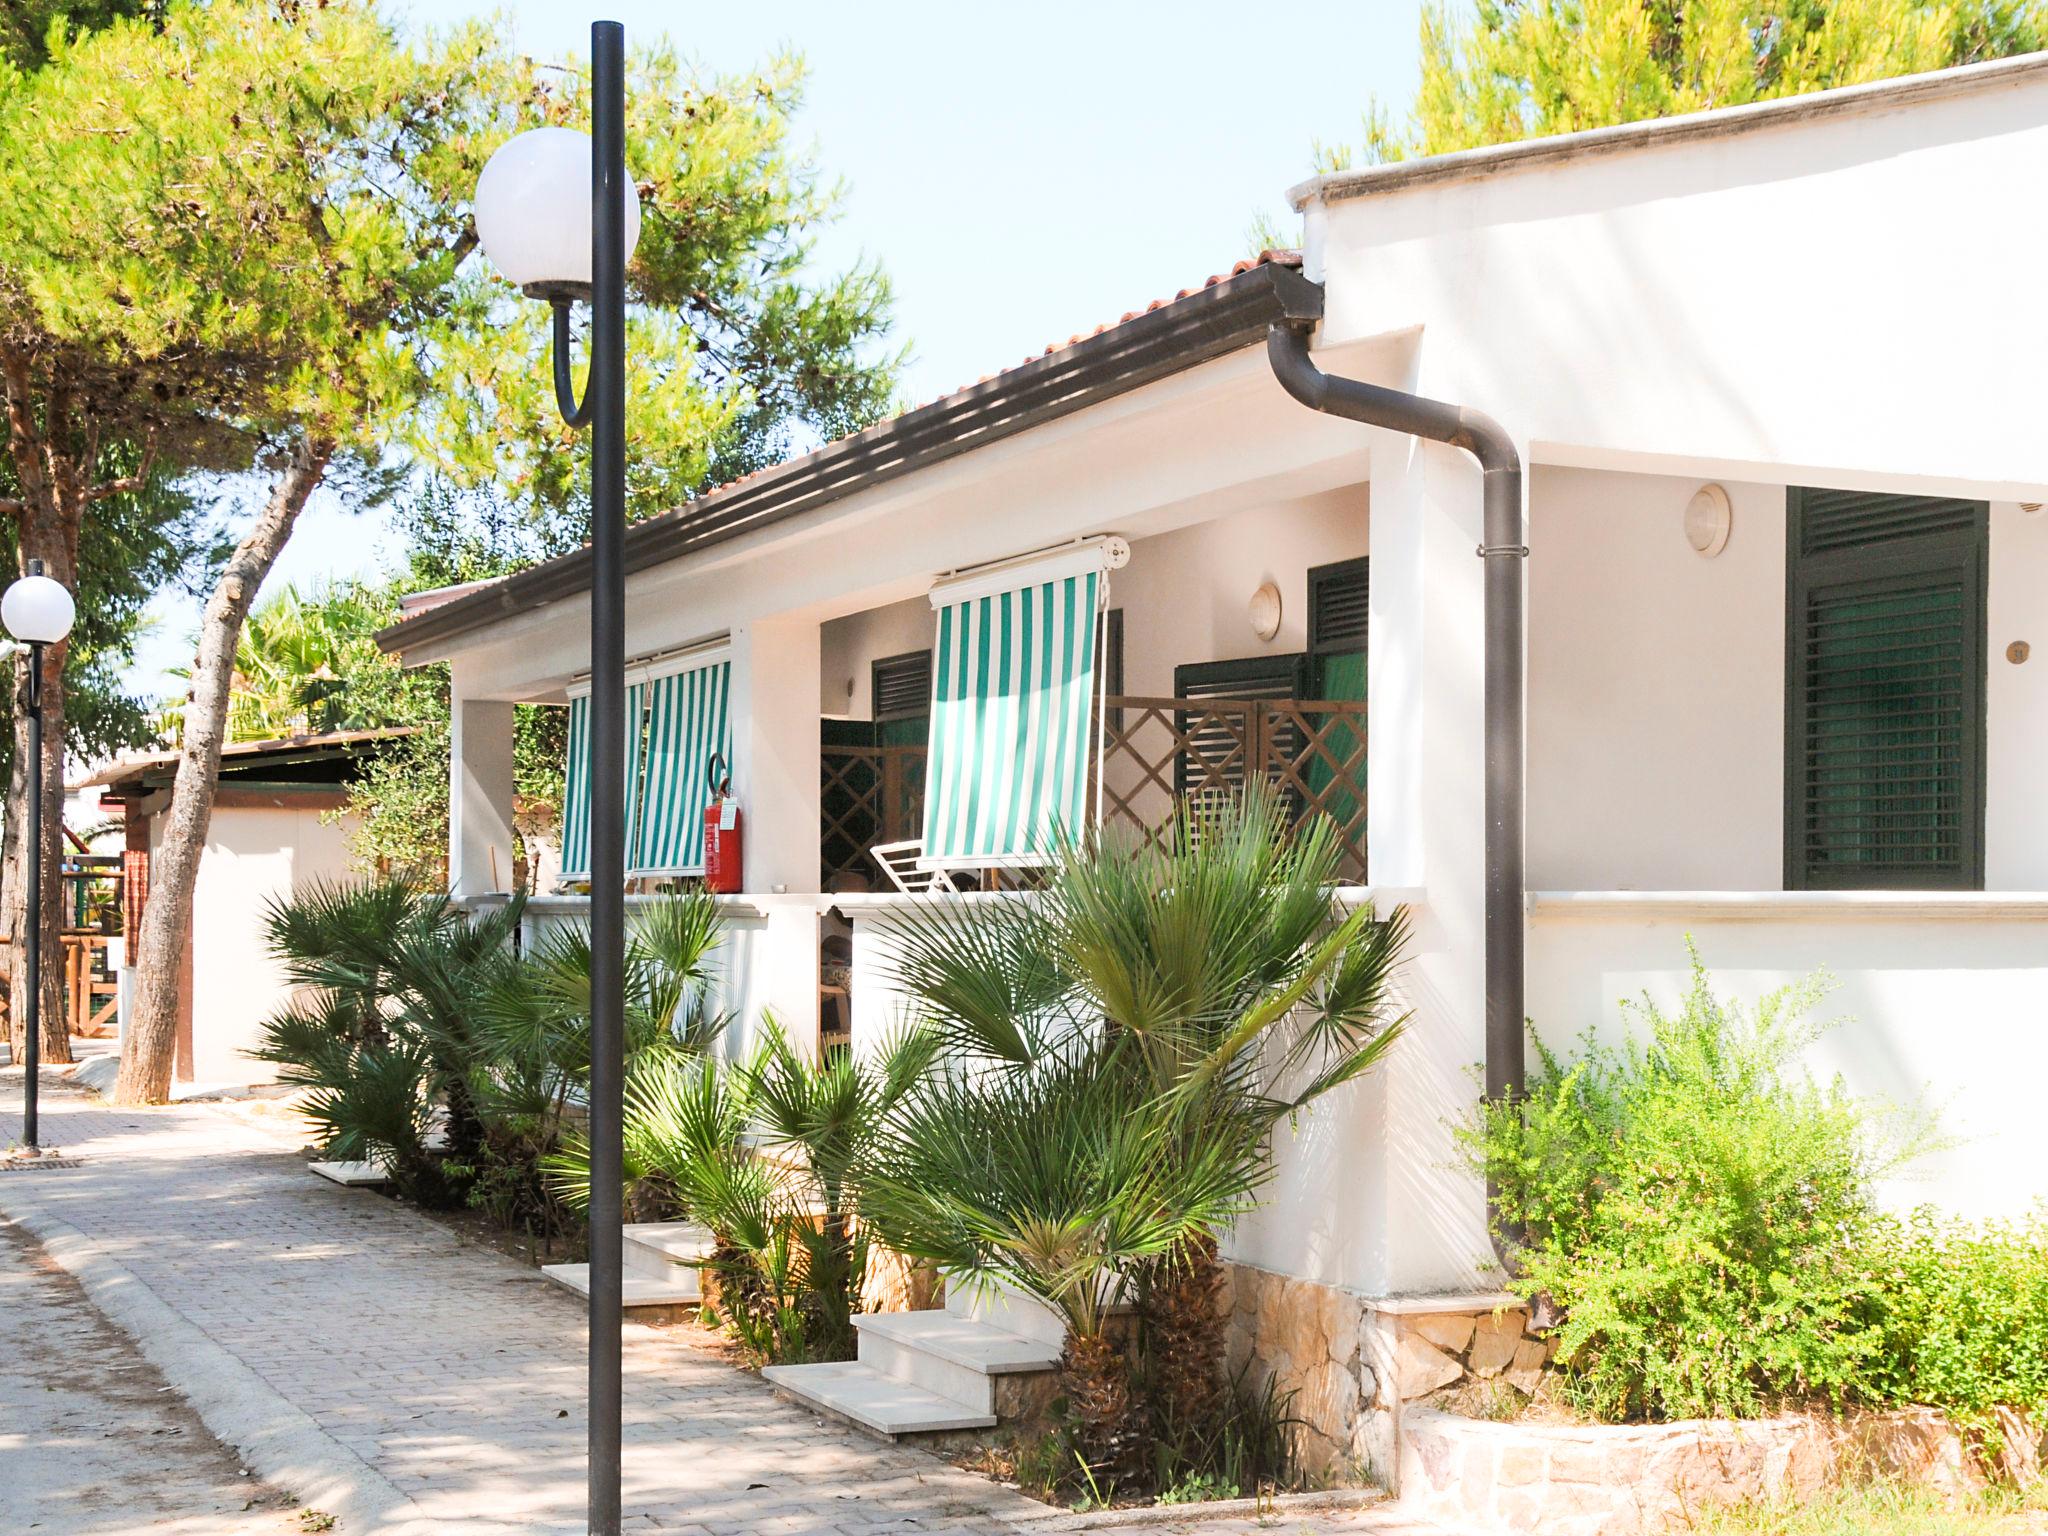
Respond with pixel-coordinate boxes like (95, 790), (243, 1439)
(74, 727), (410, 1083)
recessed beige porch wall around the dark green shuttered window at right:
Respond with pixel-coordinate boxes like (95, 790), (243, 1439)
(1528, 467), (2048, 891)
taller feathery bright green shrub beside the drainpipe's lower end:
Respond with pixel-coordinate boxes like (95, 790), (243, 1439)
(1470, 954), (1886, 1419)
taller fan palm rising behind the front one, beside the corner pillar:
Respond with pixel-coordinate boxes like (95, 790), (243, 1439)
(872, 786), (1407, 1470)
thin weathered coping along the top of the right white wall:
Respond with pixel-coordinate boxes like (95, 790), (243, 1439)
(1286, 53), (2048, 213)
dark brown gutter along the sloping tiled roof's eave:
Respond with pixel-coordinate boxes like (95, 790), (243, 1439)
(377, 262), (1323, 651)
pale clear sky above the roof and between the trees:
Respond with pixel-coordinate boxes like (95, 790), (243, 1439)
(119, 0), (1419, 692)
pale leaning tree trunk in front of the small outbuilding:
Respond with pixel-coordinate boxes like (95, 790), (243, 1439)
(115, 438), (334, 1104)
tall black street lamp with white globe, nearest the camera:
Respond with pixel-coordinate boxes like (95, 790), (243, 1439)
(477, 20), (639, 1536)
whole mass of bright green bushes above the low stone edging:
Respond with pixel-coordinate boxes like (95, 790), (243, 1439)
(1470, 954), (2048, 1456)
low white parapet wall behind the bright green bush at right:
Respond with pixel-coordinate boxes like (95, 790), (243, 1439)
(1528, 895), (2048, 1217)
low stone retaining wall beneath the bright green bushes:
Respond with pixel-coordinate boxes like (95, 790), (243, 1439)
(1401, 1403), (1978, 1536)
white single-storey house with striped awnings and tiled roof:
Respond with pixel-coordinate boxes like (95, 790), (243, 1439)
(383, 55), (2048, 1482)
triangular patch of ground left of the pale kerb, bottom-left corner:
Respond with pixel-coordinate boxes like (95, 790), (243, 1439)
(0, 1212), (303, 1536)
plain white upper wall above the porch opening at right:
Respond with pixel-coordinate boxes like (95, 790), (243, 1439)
(1309, 68), (2048, 500)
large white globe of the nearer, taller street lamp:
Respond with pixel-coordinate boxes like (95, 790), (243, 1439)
(477, 127), (639, 299)
